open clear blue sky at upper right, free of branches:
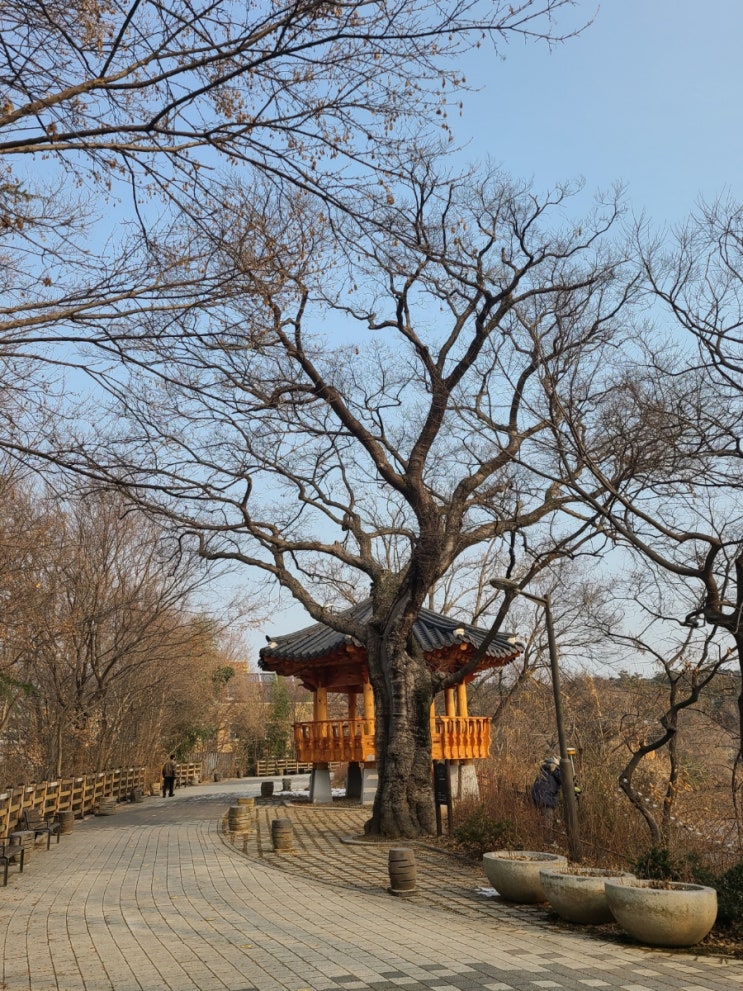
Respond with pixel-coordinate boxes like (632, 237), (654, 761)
(456, 0), (743, 224)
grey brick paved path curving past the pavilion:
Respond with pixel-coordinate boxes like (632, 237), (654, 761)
(0, 780), (743, 991)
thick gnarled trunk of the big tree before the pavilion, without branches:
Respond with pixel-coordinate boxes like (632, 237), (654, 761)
(365, 625), (436, 839)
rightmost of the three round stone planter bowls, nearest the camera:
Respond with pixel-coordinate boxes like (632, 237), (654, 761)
(604, 878), (717, 946)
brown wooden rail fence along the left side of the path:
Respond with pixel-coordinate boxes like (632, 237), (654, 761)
(0, 764), (201, 836)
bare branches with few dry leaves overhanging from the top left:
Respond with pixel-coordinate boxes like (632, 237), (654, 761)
(0, 0), (579, 360)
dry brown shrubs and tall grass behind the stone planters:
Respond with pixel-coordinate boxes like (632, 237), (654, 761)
(440, 672), (743, 957)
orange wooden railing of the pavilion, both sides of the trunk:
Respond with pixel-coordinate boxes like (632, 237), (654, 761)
(294, 716), (490, 763)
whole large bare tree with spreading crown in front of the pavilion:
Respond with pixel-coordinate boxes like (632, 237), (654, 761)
(68, 173), (633, 836)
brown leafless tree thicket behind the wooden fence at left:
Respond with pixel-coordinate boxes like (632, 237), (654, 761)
(2, 487), (227, 776)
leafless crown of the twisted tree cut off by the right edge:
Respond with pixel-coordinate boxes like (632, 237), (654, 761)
(536, 204), (743, 812)
